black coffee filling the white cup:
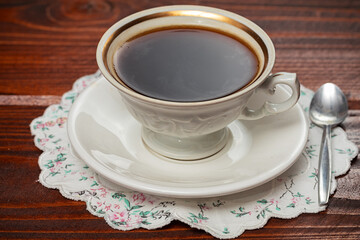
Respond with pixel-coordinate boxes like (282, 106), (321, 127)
(114, 29), (258, 102)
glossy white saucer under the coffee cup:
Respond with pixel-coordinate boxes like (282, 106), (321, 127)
(67, 79), (308, 198)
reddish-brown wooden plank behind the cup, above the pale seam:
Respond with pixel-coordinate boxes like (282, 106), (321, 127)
(0, 0), (360, 108)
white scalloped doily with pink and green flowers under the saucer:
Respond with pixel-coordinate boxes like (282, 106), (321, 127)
(30, 72), (358, 239)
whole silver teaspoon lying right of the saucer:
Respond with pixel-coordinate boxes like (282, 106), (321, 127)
(309, 83), (348, 205)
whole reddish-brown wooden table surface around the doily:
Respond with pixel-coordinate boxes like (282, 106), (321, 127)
(0, 0), (360, 239)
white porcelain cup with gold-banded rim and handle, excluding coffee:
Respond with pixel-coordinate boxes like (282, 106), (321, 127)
(96, 5), (300, 160)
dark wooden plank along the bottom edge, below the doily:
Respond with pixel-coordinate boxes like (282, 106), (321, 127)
(0, 214), (360, 239)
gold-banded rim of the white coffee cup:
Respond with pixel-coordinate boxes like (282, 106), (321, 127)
(96, 5), (275, 107)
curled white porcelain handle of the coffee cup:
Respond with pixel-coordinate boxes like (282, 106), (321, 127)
(239, 72), (300, 120)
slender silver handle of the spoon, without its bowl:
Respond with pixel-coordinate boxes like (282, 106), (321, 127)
(319, 125), (332, 205)
